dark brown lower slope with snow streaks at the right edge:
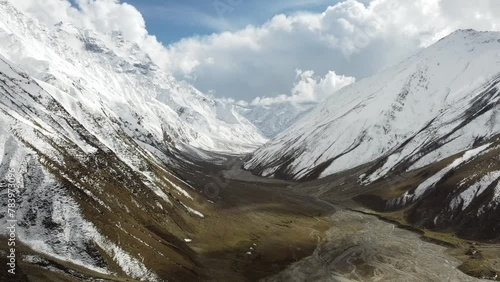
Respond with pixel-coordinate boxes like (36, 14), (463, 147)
(355, 137), (500, 242)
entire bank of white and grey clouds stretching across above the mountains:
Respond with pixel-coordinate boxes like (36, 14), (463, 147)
(8, 0), (500, 103)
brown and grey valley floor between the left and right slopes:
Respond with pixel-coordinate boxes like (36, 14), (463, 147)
(0, 154), (500, 281)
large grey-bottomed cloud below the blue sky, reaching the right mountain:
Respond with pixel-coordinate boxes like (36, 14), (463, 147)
(161, 0), (500, 101)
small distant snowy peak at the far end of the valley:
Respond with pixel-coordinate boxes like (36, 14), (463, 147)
(236, 102), (315, 138)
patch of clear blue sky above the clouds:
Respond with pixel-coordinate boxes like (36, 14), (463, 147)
(121, 0), (339, 45)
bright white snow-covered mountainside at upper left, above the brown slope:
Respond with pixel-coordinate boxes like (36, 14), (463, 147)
(0, 1), (266, 153)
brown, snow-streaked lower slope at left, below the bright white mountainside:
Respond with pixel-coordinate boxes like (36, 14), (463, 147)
(0, 54), (207, 281)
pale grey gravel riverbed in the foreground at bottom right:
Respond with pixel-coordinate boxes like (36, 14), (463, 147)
(265, 210), (490, 282)
